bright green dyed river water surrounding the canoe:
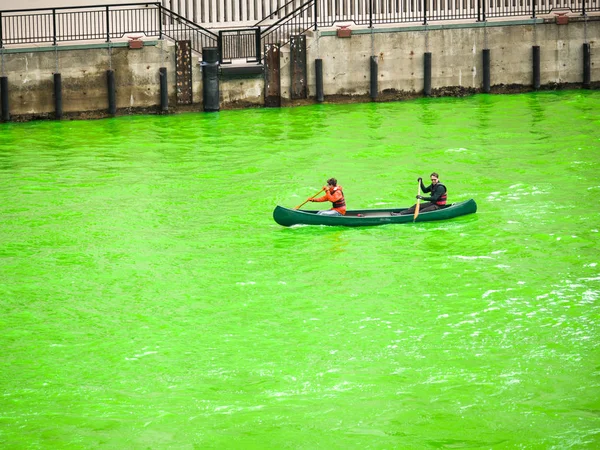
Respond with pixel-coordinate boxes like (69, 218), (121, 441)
(0, 91), (600, 449)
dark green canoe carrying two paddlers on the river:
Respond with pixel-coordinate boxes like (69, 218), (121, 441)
(273, 199), (477, 227)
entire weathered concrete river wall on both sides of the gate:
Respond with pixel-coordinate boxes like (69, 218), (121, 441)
(2, 16), (600, 120)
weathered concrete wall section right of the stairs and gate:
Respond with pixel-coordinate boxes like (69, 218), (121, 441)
(302, 21), (600, 98)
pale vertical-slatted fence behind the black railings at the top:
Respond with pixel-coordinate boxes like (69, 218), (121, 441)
(162, 0), (600, 28)
